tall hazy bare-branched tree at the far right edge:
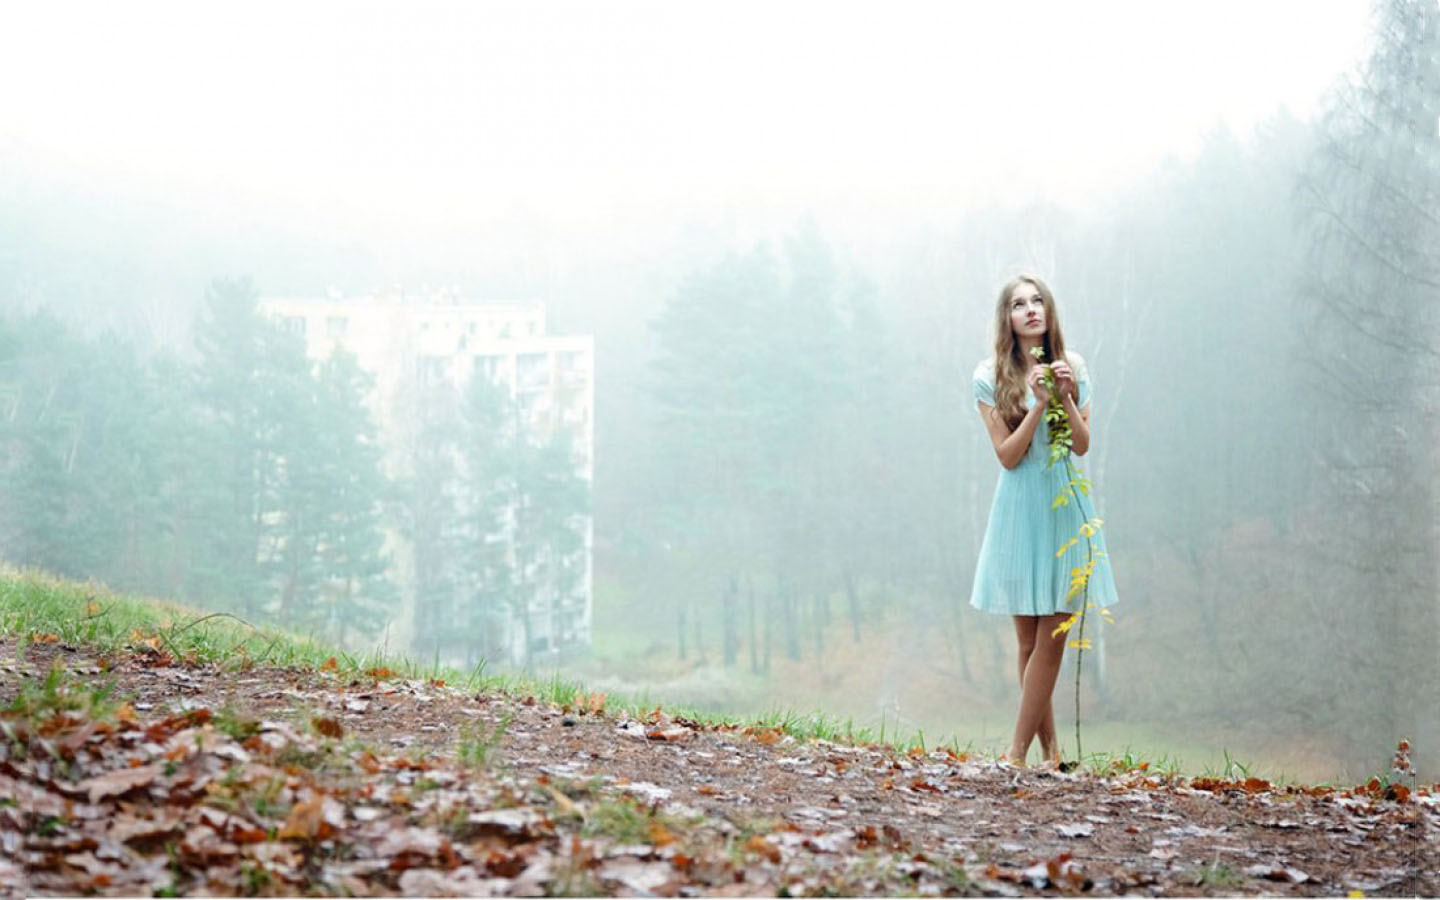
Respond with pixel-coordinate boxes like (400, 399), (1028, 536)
(1297, 0), (1440, 746)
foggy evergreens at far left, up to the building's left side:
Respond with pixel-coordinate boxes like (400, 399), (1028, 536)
(0, 281), (395, 641)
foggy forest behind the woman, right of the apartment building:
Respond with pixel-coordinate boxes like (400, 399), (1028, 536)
(613, 0), (1440, 762)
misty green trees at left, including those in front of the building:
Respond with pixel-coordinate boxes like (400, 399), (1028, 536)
(0, 281), (588, 657)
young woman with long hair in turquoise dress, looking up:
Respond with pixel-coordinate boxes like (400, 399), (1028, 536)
(971, 275), (1116, 766)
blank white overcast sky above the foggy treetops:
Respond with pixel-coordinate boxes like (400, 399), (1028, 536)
(0, 0), (1368, 246)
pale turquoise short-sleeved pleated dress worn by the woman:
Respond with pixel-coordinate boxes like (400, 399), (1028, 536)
(971, 353), (1119, 616)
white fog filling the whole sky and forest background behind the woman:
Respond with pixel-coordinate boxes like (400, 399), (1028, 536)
(0, 1), (1440, 779)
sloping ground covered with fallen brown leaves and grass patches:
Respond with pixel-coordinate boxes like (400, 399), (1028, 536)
(0, 636), (1440, 897)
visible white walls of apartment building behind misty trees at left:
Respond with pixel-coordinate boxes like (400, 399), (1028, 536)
(259, 291), (595, 662)
